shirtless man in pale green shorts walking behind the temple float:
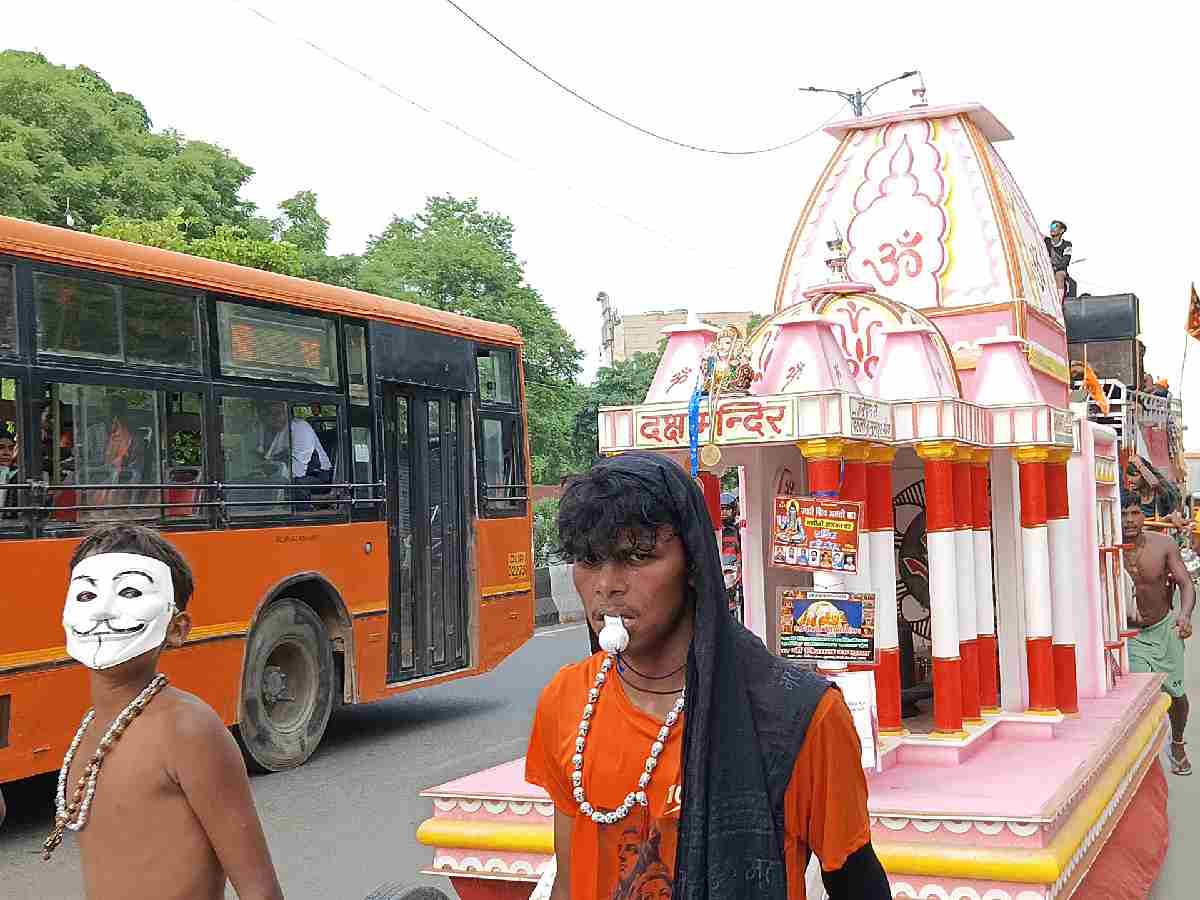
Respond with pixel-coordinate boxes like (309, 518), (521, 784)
(1121, 491), (1195, 775)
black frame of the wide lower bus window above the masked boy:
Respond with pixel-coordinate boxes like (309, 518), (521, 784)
(31, 366), (217, 538)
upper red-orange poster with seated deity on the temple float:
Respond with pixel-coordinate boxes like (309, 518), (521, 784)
(770, 496), (863, 575)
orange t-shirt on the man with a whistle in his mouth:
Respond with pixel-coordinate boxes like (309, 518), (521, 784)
(526, 653), (871, 900)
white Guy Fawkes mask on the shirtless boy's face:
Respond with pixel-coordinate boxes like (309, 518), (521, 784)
(62, 553), (176, 668)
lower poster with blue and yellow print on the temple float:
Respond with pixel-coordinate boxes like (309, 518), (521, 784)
(779, 588), (878, 665)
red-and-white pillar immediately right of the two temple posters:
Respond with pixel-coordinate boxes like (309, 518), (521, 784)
(863, 444), (908, 734)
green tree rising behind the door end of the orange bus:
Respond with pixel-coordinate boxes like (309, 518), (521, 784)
(359, 197), (583, 482)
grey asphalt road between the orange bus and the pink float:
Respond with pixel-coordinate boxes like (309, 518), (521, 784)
(0, 625), (587, 900)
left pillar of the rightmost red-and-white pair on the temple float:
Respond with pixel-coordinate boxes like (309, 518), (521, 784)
(1013, 446), (1058, 714)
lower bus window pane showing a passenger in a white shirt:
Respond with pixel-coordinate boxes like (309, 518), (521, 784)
(221, 397), (343, 517)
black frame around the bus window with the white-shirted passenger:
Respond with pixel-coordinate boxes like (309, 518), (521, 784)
(211, 382), (350, 530)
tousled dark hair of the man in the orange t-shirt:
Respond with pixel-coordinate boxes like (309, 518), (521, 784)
(558, 466), (691, 568)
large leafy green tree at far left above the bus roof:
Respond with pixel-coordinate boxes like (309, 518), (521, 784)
(0, 50), (254, 238)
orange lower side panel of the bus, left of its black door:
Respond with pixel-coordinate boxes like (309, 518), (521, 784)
(0, 522), (388, 781)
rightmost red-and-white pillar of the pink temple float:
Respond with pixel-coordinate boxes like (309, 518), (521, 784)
(1046, 446), (1079, 714)
